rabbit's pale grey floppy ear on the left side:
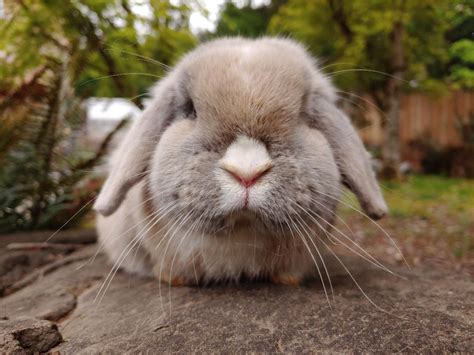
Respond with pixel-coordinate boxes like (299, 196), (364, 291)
(94, 76), (175, 216)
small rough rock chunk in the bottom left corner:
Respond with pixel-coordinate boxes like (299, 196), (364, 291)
(0, 317), (62, 354)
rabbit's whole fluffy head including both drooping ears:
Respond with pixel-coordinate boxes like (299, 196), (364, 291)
(95, 38), (386, 239)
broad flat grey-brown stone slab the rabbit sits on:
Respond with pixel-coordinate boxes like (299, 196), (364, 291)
(0, 239), (474, 353)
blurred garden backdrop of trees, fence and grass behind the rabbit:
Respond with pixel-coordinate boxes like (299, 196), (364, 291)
(0, 0), (474, 270)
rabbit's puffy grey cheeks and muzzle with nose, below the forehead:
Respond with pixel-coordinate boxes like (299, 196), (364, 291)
(148, 119), (339, 234)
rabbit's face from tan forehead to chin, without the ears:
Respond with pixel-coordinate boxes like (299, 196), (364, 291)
(148, 48), (339, 239)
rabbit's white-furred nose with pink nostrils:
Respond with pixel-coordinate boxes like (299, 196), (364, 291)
(219, 136), (273, 188)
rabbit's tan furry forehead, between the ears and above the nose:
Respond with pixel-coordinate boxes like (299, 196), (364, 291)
(183, 46), (309, 132)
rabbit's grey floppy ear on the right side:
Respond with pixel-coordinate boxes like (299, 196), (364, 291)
(306, 93), (387, 219)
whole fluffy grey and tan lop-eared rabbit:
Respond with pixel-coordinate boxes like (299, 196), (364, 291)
(94, 37), (387, 285)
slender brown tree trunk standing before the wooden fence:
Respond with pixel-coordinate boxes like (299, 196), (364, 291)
(382, 21), (405, 179)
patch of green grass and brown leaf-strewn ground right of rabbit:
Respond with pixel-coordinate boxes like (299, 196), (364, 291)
(340, 175), (474, 266)
